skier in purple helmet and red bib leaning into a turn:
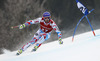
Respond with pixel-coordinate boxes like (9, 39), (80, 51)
(16, 12), (63, 55)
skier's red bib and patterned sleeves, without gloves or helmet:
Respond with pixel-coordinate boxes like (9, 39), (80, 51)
(25, 18), (61, 38)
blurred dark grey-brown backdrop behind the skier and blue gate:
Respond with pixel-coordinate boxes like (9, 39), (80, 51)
(0, 0), (100, 53)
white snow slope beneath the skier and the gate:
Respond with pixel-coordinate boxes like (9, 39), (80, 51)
(0, 29), (100, 61)
